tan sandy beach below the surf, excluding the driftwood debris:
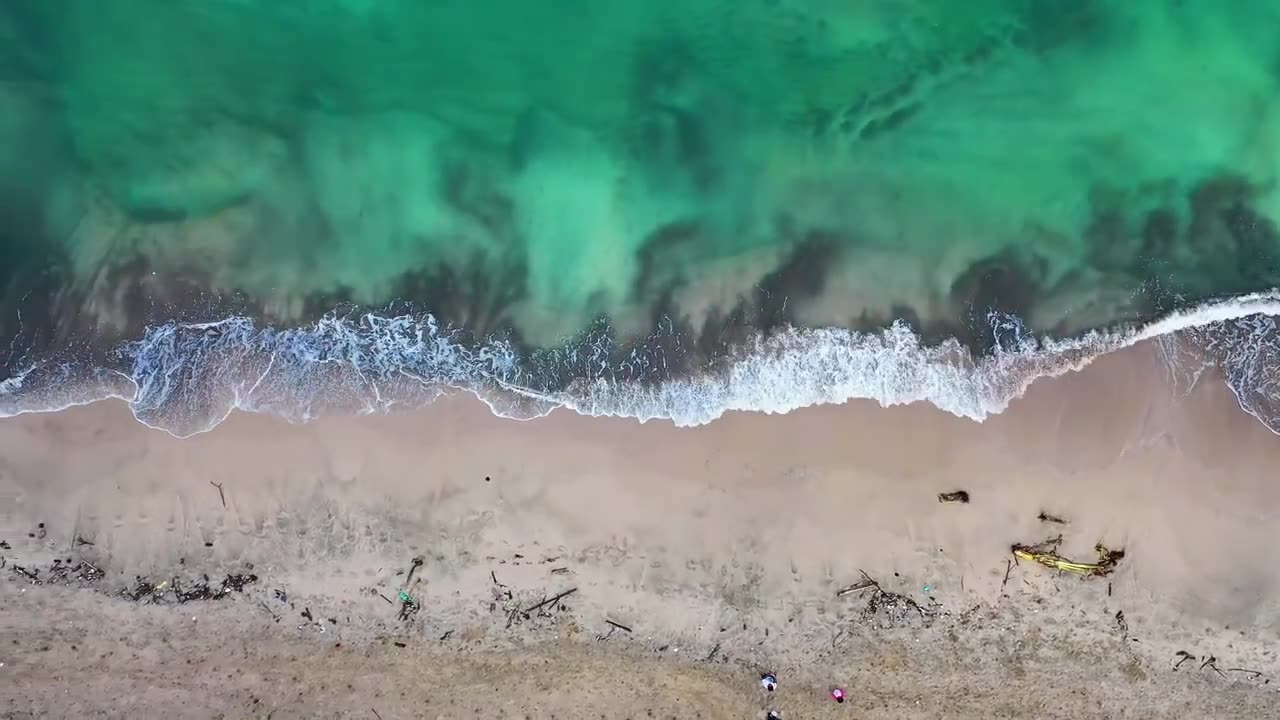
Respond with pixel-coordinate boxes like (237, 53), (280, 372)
(0, 338), (1280, 720)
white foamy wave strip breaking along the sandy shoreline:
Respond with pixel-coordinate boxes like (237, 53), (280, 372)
(0, 292), (1280, 437)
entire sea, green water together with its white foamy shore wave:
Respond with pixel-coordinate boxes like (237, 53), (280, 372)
(0, 0), (1280, 434)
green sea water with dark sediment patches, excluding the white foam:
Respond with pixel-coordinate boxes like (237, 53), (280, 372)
(0, 0), (1280, 345)
